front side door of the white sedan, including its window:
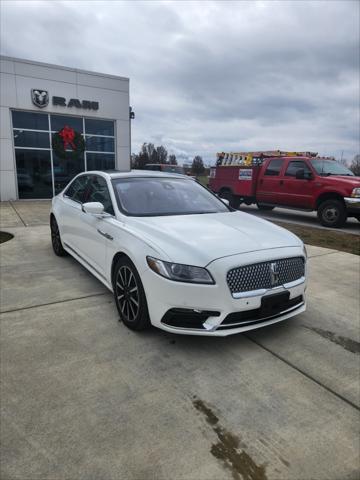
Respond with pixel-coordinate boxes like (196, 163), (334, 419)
(76, 175), (115, 277)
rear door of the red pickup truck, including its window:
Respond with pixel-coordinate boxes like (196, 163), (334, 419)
(256, 158), (284, 204)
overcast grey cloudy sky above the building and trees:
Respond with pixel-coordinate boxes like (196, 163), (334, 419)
(1, 0), (359, 162)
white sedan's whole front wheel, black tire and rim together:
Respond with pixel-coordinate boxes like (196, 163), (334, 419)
(113, 257), (150, 330)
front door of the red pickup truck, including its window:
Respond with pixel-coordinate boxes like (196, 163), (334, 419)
(279, 160), (314, 208)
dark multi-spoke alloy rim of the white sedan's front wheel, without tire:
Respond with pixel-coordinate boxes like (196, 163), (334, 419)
(115, 265), (140, 322)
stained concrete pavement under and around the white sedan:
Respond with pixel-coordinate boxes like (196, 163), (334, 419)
(0, 202), (360, 480)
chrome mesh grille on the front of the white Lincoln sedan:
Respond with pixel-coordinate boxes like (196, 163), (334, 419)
(226, 257), (305, 293)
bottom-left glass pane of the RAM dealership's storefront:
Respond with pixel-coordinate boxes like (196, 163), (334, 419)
(15, 149), (53, 198)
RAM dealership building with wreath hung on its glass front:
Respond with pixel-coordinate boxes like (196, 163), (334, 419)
(0, 56), (130, 200)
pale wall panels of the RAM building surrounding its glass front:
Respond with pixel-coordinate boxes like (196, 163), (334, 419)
(0, 57), (130, 200)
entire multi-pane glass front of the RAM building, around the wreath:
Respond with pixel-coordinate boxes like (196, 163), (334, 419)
(12, 110), (115, 198)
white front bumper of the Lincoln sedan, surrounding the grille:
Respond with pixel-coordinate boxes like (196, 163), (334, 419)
(142, 247), (306, 336)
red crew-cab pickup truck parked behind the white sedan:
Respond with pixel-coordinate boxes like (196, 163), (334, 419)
(209, 156), (360, 227)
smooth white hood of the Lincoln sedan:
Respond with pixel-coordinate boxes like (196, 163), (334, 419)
(127, 212), (302, 266)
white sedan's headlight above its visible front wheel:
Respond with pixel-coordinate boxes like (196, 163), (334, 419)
(146, 257), (215, 284)
